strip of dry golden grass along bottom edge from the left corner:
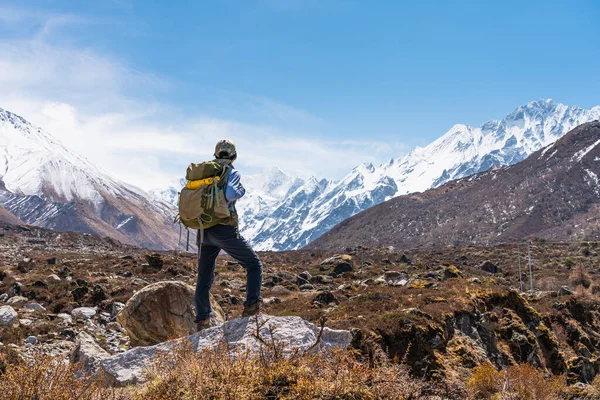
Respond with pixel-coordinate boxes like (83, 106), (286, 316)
(0, 347), (423, 400)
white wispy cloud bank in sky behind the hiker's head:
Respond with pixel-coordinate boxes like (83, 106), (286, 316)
(0, 5), (404, 189)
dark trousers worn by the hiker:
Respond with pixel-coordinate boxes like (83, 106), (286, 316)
(195, 225), (262, 321)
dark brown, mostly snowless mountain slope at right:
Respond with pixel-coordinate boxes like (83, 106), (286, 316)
(307, 121), (600, 249)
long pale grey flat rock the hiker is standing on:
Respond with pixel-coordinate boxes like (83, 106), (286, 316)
(100, 315), (352, 386)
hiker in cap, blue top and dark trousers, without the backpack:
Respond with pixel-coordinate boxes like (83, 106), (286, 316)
(190, 139), (262, 331)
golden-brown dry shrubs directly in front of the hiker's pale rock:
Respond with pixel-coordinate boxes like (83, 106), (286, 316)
(134, 340), (422, 400)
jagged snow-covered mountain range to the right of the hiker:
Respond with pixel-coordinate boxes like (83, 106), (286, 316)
(151, 100), (600, 250)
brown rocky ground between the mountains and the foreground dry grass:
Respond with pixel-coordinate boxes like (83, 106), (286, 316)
(0, 225), (600, 396)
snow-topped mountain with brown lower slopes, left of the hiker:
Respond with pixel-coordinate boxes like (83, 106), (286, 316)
(0, 109), (179, 249)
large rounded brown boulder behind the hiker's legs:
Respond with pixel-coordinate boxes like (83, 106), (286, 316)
(117, 281), (224, 346)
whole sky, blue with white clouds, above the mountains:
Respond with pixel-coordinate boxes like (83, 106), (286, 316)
(0, 0), (600, 184)
